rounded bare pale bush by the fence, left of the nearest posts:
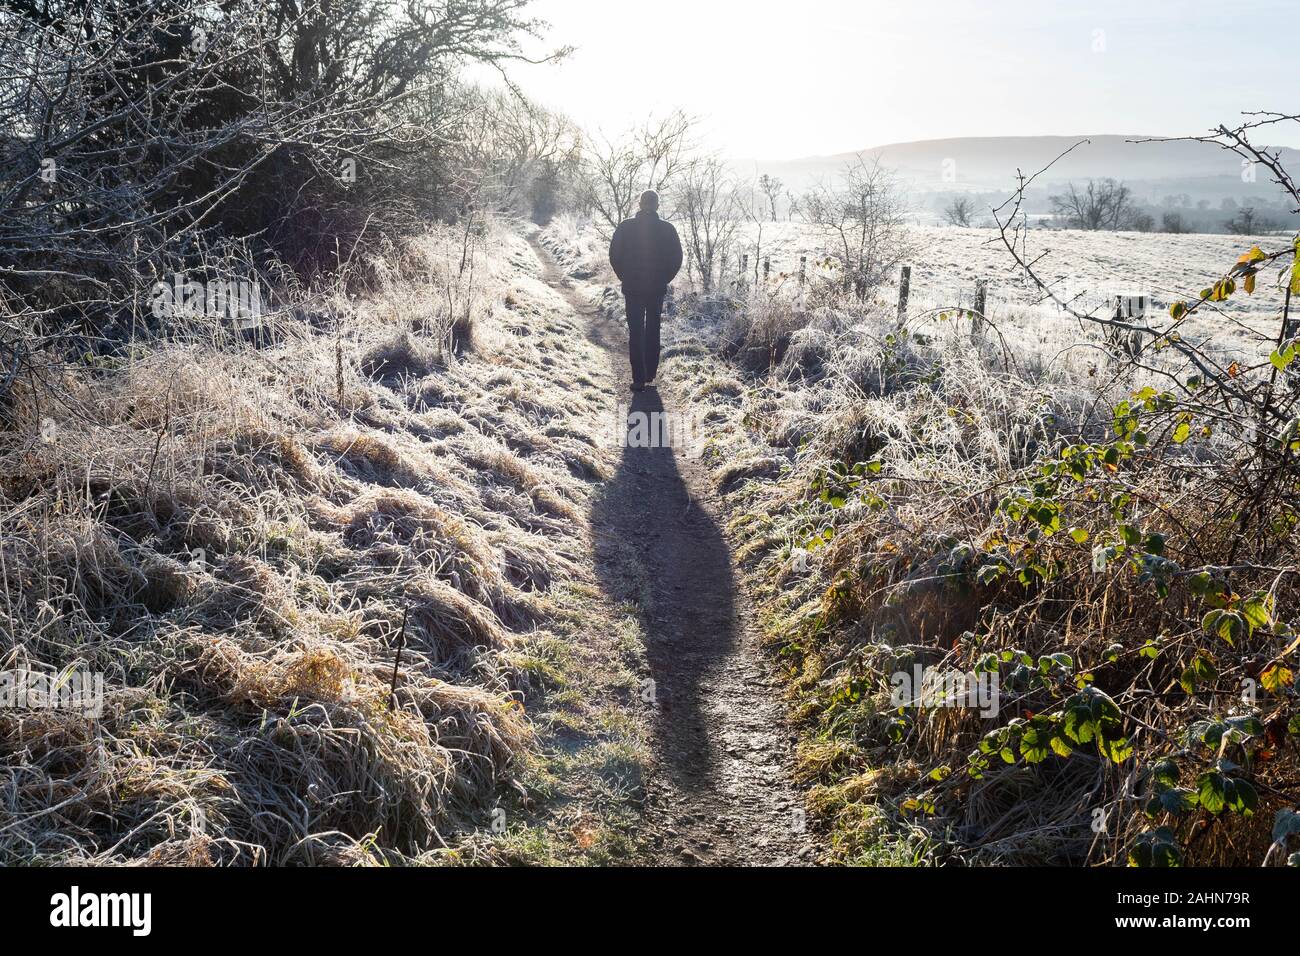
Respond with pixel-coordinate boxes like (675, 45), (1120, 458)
(801, 156), (910, 298)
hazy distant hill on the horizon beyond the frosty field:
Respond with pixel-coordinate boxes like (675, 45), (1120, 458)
(736, 134), (1300, 202)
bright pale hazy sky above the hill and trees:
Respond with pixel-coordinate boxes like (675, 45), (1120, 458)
(491, 0), (1300, 159)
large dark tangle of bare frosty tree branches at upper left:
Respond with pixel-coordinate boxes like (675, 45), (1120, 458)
(0, 0), (561, 325)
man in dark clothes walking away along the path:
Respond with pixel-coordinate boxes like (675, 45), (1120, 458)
(610, 190), (681, 392)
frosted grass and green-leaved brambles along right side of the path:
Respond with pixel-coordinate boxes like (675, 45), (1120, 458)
(548, 214), (1300, 865)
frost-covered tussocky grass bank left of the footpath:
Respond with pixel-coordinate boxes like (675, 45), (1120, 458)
(0, 218), (644, 864)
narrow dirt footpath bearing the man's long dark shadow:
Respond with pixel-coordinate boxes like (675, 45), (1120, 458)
(525, 234), (820, 865)
